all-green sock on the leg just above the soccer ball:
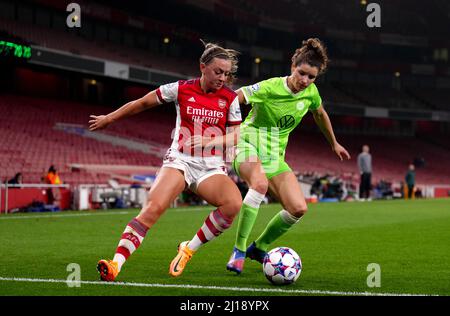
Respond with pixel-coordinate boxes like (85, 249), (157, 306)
(255, 210), (300, 251)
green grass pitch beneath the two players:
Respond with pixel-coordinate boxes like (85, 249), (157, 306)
(0, 199), (450, 296)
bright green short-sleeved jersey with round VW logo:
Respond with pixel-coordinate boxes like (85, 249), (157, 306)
(241, 77), (322, 160)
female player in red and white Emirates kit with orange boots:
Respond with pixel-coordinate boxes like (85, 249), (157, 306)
(89, 43), (242, 281)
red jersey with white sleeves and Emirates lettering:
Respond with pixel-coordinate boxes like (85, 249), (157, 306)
(156, 78), (242, 156)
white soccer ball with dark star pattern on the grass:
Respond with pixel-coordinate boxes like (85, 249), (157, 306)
(263, 247), (302, 285)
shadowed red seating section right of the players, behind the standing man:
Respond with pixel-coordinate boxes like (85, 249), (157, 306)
(286, 131), (450, 184)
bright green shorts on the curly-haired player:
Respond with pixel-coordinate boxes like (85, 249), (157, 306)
(232, 141), (292, 180)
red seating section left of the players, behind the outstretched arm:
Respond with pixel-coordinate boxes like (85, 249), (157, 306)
(0, 95), (174, 185)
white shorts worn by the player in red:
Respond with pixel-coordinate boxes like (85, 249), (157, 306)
(162, 149), (228, 193)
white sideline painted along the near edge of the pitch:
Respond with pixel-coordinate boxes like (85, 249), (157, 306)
(0, 277), (439, 296)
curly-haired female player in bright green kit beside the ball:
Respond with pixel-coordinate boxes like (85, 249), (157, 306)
(227, 38), (350, 274)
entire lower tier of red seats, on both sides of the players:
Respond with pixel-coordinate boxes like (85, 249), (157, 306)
(0, 95), (450, 189)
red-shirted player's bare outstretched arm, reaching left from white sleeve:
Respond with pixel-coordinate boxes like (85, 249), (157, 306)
(89, 91), (160, 131)
